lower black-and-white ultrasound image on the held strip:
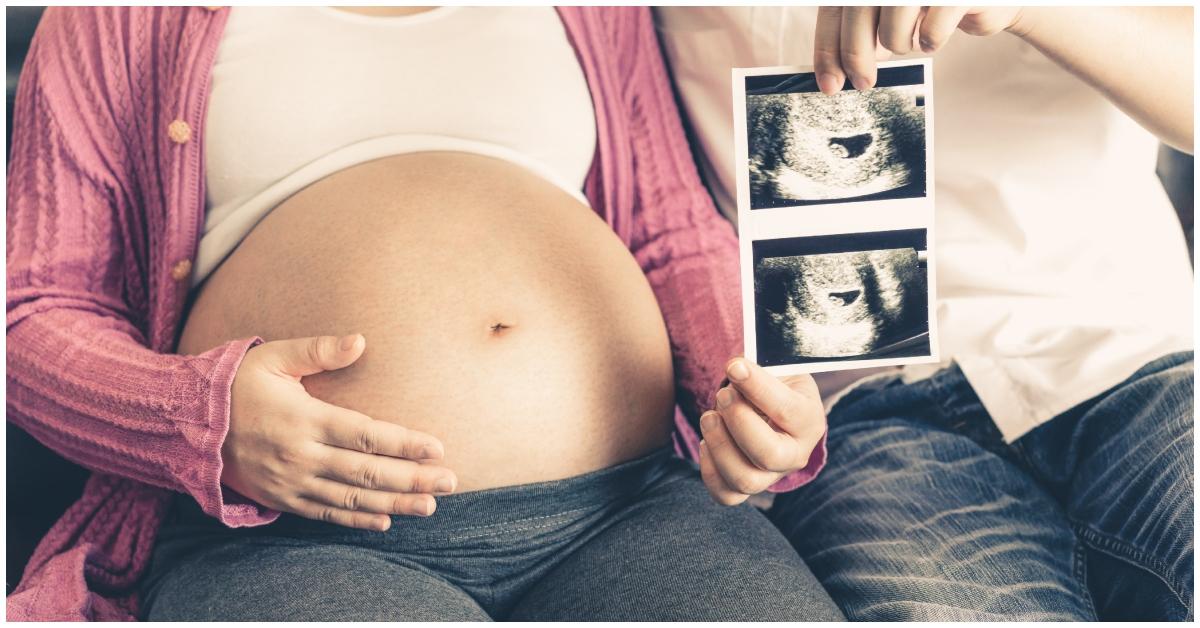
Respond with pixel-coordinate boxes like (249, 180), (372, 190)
(754, 229), (930, 366)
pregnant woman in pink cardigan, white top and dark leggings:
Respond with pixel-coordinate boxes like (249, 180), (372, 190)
(7, 7), (839, 621)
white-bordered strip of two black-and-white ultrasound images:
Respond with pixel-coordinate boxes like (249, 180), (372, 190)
(733, 59), (938, 375)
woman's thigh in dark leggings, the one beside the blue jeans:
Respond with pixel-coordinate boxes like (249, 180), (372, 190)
(515, 477), (844, 621)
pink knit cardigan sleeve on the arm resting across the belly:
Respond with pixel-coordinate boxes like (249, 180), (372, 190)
(6, 7), (278, 526)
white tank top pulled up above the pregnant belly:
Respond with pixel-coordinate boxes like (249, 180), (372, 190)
(192, 6), (596, 288)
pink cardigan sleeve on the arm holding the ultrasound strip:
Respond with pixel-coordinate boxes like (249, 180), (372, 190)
(623, 7), (826, 492)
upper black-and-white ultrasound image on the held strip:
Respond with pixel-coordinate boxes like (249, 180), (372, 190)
(746, 71), (925, 209)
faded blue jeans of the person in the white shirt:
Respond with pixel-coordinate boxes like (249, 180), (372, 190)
(769, 352), (1194, 621)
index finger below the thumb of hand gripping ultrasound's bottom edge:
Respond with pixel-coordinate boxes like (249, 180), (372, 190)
(716, 387), (812, 473)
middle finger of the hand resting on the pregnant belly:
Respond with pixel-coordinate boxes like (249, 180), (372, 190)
(317, 447), (458, 495)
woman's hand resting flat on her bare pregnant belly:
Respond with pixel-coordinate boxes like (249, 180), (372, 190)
(221, 334), (457, 531)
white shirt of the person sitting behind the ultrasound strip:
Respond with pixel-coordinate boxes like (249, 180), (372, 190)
(656, 6), (1193, 442)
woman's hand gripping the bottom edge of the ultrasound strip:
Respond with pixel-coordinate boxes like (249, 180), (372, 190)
(700, 358), (826, 506)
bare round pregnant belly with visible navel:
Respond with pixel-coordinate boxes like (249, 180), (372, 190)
(179, 152), (674, 491)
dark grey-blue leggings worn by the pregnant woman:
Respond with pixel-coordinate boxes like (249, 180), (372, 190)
(142, 449), (842, 621)
